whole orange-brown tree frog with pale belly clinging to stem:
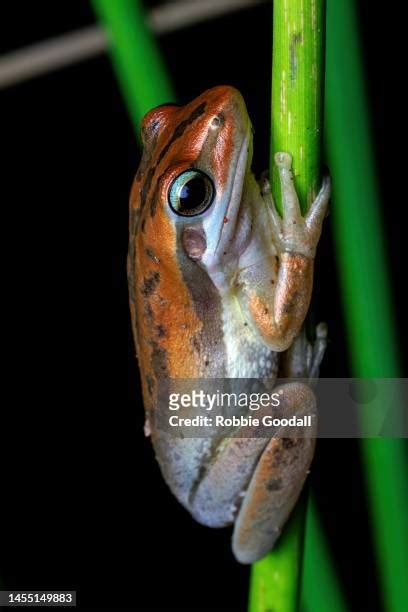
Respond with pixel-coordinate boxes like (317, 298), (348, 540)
(127, 85), (330, 564)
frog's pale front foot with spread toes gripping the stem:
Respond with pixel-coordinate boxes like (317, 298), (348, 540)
(262, 153), (330, 259)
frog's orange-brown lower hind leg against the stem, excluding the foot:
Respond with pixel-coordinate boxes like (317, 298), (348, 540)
(232, 381), (316, 563)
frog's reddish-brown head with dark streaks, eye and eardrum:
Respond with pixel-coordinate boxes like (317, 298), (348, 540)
(132, 86), (252, 285)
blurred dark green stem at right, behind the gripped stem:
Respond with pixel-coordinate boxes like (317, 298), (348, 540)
(325, 0), (408, 612)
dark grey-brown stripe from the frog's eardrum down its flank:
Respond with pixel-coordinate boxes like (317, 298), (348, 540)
(177, 227), (226, 378)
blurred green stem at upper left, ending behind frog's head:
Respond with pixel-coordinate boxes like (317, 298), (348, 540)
(92, 0), (175, 135)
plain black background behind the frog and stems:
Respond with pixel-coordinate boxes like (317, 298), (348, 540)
(0, 0), (407, 612)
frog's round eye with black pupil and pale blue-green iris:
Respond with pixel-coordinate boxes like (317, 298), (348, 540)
(169, 170), (215, 217)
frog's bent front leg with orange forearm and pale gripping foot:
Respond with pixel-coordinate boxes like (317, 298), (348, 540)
(239, 153), (330, 351)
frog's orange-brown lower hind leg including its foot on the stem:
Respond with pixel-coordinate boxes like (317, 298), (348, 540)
(233, 323), (327, 563)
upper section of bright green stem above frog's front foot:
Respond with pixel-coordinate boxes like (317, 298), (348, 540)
(270, 0), (325, 213)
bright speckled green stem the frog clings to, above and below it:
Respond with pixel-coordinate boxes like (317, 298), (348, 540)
(249, 0), (332, 612)
